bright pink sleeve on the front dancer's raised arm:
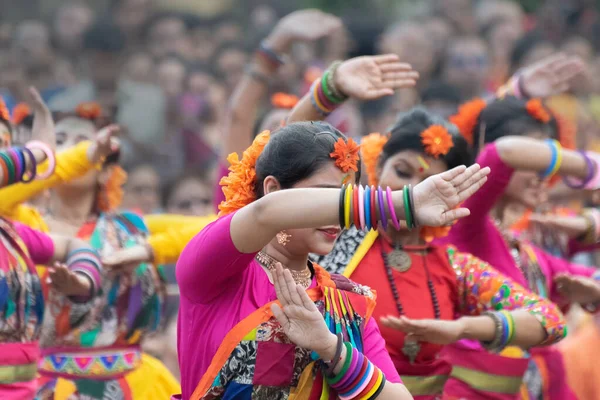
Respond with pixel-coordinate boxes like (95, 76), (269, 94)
(175, 213), (256, 304)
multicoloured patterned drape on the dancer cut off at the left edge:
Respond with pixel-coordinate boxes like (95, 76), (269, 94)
(0, 218), (44, 343)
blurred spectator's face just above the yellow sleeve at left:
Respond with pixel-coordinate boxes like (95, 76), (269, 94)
(122, 164), (160, 214)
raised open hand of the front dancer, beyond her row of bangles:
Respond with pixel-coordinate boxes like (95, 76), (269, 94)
(413, 164), (490, 226)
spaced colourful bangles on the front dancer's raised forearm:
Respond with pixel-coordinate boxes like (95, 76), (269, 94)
(338, 185), (417, 230)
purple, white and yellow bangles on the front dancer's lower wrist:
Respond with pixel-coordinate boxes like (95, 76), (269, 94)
(325, 342), (386, 400)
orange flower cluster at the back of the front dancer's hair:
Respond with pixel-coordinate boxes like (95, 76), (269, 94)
(219, 131), (271, 217)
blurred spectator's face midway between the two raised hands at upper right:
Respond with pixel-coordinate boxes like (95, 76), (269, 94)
(441, 36), (490, 99)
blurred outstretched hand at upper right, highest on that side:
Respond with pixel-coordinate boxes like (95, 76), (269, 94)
(521, 53), (586, 98)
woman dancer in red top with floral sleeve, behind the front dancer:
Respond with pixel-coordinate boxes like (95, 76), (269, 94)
(291, 69), (566, 399)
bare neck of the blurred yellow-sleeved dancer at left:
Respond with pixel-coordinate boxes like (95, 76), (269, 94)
(49, 187), (96, 223)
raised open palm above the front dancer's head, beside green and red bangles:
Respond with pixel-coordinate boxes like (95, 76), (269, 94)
(335, 54), (419, 100)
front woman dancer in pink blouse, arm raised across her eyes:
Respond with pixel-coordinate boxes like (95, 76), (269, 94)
(177, 117), (487, 399)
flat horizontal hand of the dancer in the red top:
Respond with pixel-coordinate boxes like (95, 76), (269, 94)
(381, 316), (464, 344)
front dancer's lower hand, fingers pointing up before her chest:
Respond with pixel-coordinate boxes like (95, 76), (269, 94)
(271, 264), (337, 357)
